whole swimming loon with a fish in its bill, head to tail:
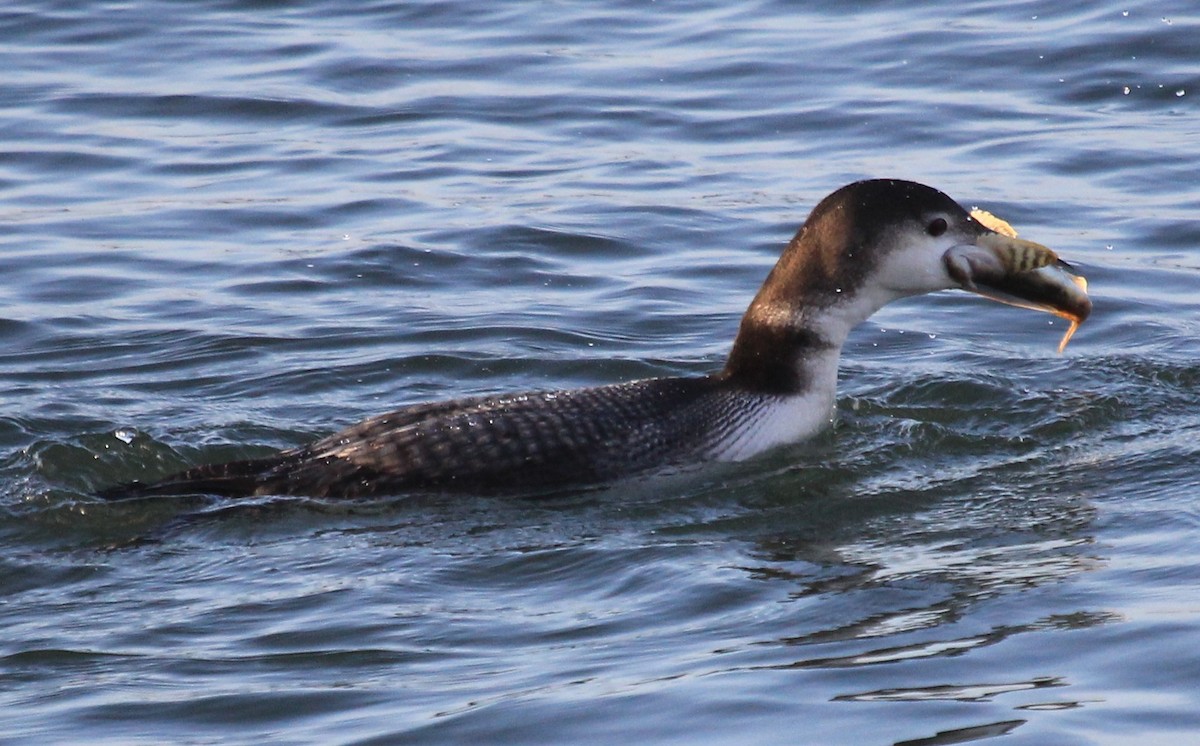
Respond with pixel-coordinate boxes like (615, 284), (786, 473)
(101, 179), (1092, 499)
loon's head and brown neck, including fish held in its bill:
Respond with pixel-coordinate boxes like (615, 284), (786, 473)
(724, 179), (1091, 392)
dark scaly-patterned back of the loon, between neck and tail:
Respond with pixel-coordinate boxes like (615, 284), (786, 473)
(256, 378), (779, 497)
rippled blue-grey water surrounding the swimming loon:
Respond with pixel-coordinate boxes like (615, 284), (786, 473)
(0, 0), (1200, 745)
